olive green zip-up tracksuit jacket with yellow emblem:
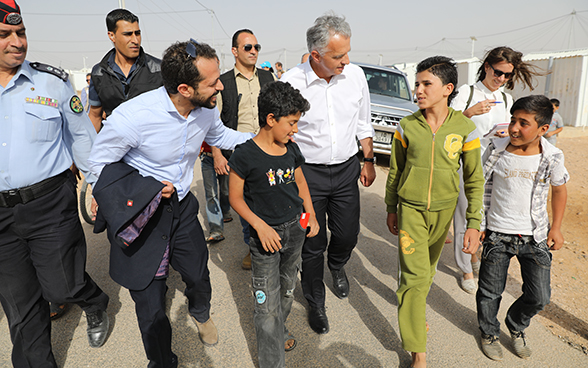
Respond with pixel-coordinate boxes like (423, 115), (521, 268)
(385, 108), (484, 230)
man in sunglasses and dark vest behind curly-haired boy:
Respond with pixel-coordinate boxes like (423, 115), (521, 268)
(201, 29), (275, 270)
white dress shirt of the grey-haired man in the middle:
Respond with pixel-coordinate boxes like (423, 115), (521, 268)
(280, 61), (374, 165)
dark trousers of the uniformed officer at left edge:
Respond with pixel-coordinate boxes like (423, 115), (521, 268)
(0, 175), (108, 368)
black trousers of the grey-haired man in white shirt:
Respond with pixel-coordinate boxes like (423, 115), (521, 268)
(301, 156), (361, 308)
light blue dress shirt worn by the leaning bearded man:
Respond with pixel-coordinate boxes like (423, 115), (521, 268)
(88, 87), (253, 200)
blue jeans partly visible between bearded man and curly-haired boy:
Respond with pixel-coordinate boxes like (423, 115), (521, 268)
(200, 154), (231, 234)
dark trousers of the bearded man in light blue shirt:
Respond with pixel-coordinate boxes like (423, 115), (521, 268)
(130, 193), (212, 368)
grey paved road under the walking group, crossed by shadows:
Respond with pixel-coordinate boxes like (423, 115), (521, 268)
(0, 162), (588, 368)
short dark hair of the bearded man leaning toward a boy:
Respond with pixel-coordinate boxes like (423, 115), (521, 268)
(161, 41), (218, 95)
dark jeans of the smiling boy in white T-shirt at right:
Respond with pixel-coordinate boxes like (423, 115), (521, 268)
(476, 230), (551, 336)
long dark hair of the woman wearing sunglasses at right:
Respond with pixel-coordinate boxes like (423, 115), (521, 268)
(478, 46), (544, 91)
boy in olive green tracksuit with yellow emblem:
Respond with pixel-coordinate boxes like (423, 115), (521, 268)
(386, 56), (484, 367)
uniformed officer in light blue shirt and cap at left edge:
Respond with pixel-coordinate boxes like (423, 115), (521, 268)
(0, 0), (108, 367)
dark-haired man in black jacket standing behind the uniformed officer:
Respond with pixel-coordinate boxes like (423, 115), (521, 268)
(89, 9), (163, 132)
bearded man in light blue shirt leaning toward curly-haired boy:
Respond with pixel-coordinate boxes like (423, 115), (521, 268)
(88, 40), (253, 367)
